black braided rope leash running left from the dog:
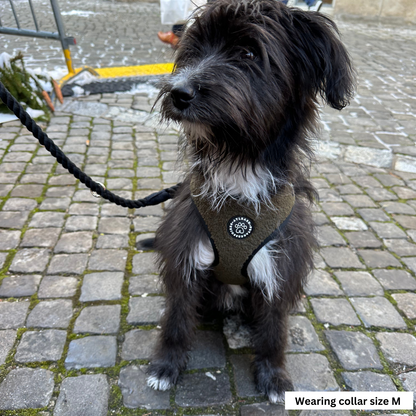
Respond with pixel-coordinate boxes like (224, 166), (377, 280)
(0, 81), (181, 208)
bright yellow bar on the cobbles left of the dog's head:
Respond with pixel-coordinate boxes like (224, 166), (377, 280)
(59, 63), (173, 86)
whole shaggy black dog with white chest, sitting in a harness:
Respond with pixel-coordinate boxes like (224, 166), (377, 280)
(148, 0), (354, 402)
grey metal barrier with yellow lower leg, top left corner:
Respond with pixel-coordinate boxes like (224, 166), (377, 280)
(0, 0), (76, 74)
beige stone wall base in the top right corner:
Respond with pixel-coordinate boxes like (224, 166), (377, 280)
(334, 0), (416, 23)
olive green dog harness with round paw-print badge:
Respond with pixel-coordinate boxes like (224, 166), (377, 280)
(191, 175), (295, 285)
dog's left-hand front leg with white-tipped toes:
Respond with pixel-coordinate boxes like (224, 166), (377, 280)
(147, 270), (201, 390)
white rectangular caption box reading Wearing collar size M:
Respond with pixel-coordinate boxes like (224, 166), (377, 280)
(285, 391), (413, 410)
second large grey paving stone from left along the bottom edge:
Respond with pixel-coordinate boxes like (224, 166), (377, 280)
(54, 374), (110, 416)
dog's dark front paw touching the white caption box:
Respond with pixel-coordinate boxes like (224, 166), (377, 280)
(255, 365), (293, 403)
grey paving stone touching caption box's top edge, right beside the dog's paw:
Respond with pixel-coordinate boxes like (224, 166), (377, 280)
(286, 353), (339, 391)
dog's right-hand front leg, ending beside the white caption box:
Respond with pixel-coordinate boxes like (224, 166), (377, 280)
(252, 292), (293, 403)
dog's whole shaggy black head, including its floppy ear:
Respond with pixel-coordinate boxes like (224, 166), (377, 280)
(160, 0), (353, 158)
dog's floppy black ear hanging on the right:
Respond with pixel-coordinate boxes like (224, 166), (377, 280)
(290, 8), (355, 110)
